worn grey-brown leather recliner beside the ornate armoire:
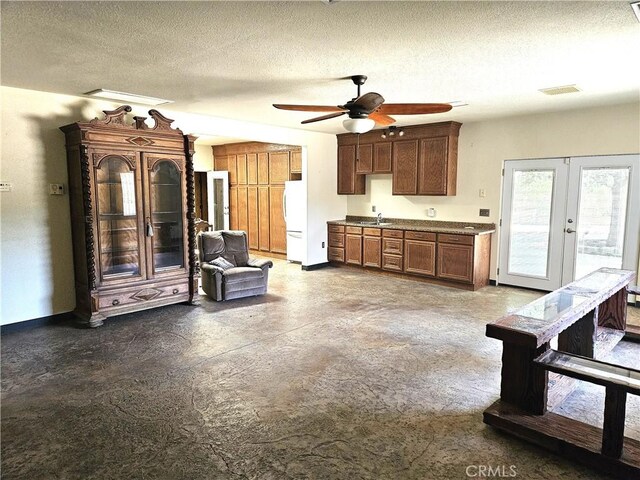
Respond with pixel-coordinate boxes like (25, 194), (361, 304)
(196, 230), (273, 301)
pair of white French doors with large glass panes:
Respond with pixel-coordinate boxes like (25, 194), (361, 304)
(498, 155), (640, 291)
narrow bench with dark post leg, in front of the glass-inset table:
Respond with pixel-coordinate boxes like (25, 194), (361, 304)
(535, 350), (640, 458)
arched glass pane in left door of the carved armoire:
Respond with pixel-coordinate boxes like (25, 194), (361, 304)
(96, 156), (140, 279)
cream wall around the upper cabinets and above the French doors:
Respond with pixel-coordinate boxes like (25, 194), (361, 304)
(347, 103), (640, 279)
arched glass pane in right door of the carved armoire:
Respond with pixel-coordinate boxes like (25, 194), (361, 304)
(150, 160), (184, 271)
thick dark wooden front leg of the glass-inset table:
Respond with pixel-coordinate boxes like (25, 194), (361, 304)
(500, 342), (549, 415)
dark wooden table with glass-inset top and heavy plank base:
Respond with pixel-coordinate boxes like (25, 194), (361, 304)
(483, 268), (640, 479)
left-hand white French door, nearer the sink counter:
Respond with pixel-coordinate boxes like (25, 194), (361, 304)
(498, 158), (568, 291)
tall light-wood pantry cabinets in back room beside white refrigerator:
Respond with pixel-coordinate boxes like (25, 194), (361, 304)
(212, 142), (302, 254)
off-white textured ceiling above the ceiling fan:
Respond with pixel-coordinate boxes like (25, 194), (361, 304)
(1, 1), (640, 137)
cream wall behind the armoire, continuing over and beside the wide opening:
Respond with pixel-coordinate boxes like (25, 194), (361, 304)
(0, 87), (346, 324)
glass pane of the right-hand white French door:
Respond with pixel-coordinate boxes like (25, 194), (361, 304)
(574, 168), (630, 278)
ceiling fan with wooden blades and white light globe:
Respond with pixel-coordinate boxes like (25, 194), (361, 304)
(273, 75), (452, 133)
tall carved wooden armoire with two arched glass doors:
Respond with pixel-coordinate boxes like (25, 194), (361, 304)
(60, 105), (197, 327)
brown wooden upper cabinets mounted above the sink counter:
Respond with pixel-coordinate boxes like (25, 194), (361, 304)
(337, 122), (462, 195)
